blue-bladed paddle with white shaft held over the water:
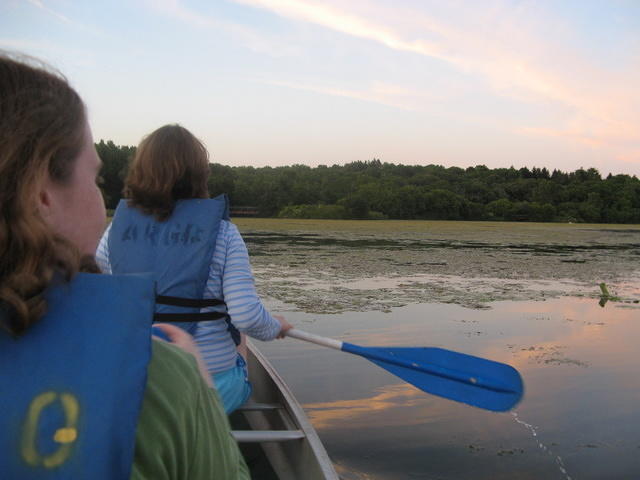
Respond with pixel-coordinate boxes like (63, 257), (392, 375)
(286, 328), (524, 412)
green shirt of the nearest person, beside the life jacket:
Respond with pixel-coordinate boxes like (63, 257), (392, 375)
(131, 341), (250, 480)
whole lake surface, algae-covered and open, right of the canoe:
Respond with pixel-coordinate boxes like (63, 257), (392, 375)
(236, 219), (640, 480)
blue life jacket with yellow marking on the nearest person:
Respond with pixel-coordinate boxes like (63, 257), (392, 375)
(0, 273), (154, 480)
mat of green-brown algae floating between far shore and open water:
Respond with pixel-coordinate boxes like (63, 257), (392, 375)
(236, 219), (640, 313)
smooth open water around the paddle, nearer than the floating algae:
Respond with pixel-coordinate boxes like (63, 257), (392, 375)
(252, 297), (640, 480)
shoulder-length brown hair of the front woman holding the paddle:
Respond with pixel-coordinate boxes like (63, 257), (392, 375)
(124, 125), (209, 221)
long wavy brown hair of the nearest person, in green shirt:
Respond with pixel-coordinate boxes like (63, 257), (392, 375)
(0, 51), (97, 335)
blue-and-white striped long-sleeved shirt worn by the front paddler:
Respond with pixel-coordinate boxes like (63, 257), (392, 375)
(96, 220), (280, 374)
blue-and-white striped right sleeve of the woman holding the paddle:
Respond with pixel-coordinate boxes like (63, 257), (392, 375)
(222, 222), (280, 340)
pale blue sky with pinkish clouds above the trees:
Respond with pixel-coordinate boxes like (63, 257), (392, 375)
(0, 0), (640, 176)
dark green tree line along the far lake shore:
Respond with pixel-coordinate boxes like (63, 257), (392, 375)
(96, 140), (640, 223)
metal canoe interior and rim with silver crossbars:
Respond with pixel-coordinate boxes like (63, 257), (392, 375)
(230, 342), (339, 480)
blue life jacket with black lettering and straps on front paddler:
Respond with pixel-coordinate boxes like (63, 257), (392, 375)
(108, 195), (239, 344)
